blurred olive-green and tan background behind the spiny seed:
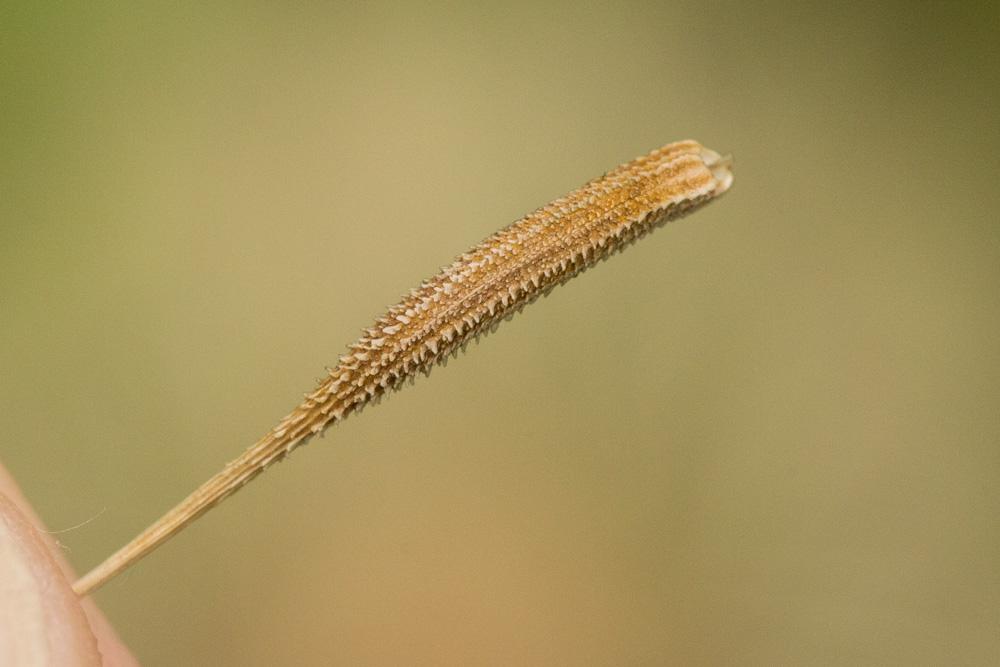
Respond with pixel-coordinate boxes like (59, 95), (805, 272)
(0, 2), (1000, 665)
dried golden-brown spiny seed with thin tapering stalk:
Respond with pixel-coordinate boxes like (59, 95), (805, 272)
(74, 141), (732, 595)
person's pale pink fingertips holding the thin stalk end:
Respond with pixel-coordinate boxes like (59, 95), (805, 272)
(0, 465), (139, 667)
